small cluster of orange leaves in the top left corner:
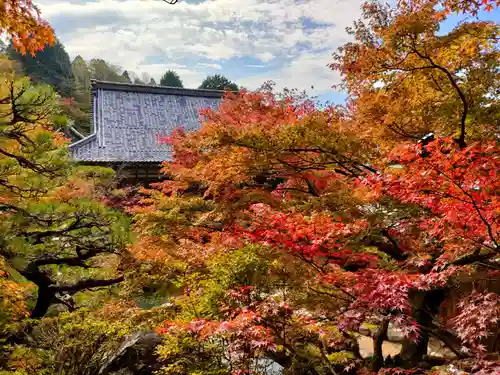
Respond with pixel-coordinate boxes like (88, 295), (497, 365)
(0, 0), (56, 55)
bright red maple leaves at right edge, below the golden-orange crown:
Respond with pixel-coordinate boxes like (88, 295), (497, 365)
(363, 139), (500, 261)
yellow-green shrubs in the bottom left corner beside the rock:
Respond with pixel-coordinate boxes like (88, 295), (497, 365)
(0, 303), (171, 375)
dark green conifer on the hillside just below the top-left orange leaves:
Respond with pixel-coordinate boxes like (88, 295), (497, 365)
(7, 41), (73, 97)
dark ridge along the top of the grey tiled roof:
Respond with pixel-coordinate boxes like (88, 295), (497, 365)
(90, 79), (229, 98)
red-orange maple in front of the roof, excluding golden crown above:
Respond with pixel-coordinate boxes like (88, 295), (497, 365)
(131, 98), (499, 371)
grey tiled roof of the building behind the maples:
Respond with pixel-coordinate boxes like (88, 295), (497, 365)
(69, 81), (223, 163)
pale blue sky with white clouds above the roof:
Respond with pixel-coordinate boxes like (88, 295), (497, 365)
(35, 0), (500, 103)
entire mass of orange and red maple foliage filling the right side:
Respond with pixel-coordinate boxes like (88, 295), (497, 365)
(128, 1), (500, 374)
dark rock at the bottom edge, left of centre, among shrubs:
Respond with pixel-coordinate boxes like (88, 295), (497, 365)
(99, 332), (162, 375)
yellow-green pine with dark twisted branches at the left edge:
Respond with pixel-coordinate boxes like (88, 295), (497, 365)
(0, 75), (128, 320)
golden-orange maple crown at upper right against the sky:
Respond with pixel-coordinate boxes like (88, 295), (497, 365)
(331, 1), (498, 147)
